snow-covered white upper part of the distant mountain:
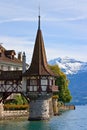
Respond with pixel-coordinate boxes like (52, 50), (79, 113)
(49, 57), (87, 75)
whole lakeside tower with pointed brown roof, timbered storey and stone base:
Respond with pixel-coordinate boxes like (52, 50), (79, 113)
(23, 16), (55, 120)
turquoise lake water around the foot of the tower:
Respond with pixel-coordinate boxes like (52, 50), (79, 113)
(0, 105), (87, 130)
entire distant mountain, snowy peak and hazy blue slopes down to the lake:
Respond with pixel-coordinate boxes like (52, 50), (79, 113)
(49, 57), (87, 105)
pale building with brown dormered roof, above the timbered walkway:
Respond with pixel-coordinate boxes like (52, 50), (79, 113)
(0, 44), (22, 71)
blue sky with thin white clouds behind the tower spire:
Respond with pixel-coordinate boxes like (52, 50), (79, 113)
(0, 0), (87, 62)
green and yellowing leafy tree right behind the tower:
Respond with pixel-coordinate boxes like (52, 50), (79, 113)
(49, 65), (72, 103)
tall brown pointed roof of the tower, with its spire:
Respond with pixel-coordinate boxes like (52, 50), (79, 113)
(24, 16), (54, 76)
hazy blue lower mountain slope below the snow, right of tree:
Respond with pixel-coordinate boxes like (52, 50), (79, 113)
(68, 72), (87, 105)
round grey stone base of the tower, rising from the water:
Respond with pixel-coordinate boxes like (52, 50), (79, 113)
(29, 98), (53, 120)
